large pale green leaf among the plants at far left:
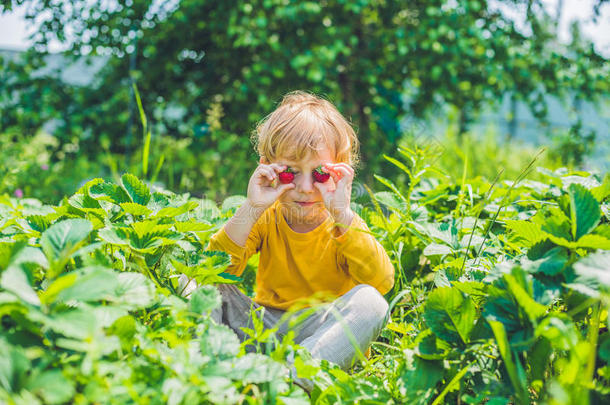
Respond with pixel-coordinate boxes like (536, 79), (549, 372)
(40, 219), (93, 261)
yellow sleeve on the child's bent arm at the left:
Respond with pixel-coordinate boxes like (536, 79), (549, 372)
(206, 216), (263, 276)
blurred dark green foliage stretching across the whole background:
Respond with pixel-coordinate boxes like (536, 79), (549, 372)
(0, 0), (608, 199)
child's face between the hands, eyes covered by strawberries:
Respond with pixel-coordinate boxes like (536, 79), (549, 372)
(264, 147), (335, 224)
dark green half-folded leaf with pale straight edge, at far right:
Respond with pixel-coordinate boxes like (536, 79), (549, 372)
(568, 184), (601, 240)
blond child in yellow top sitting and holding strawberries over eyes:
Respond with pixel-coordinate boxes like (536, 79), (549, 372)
(202, 91), (394, 388)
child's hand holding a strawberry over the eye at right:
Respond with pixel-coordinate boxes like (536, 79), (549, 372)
(314, 163), (354, 226)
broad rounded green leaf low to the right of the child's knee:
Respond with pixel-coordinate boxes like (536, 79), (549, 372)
(424, 287), (477, 343)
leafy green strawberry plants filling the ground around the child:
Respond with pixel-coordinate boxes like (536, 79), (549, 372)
(0, 141), (610, 405)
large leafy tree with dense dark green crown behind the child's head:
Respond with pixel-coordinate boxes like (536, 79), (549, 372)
(2, 0), (608, 195)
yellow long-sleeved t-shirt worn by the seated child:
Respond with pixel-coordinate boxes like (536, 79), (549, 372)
(208, 201), (394, 309)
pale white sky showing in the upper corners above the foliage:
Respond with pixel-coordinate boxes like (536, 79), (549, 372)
(0, 0), (610, 57)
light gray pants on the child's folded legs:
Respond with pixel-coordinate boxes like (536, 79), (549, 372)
(211, 284), (388, 369)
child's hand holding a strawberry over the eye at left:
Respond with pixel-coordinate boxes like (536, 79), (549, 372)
(247, 163), (295, 209)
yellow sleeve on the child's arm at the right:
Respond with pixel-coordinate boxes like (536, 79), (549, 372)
(333, 214), (394, 294)
